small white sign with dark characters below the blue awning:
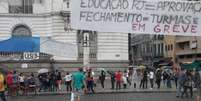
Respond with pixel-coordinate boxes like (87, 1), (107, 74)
(23, 52), (39, 60)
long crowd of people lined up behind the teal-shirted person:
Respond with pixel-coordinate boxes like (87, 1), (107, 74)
(0, 68), (201, 101)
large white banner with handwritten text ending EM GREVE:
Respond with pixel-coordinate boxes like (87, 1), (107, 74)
(71, 0), (201, 36)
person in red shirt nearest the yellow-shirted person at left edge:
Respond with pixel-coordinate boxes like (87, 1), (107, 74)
(6, 72), (13, 94)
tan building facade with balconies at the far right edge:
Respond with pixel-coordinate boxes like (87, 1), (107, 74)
(176, 36), (201, 63)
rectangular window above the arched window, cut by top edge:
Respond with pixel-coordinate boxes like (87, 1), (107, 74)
(9, 0), (33, 14)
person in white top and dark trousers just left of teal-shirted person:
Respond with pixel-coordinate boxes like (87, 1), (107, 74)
(64, 72), (72, 92)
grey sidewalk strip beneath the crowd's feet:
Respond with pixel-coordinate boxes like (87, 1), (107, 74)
(22, 80), (182, 95)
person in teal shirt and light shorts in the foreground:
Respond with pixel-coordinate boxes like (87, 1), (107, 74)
(71, 68), (85, 101)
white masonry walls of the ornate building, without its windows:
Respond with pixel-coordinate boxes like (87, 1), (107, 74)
(0, 0), (128, 70)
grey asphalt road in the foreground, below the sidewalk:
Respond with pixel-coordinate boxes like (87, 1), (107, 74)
(8, 93), (195, 101)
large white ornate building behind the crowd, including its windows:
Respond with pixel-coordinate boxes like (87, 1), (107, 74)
(0, 0), (128, 71)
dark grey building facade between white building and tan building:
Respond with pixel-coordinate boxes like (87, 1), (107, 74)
(130, 34), (164, 66)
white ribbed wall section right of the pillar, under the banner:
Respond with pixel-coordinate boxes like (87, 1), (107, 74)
(98, 33), (128, 60)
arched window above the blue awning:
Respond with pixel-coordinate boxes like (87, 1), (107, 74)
(12, 25), (32, 37)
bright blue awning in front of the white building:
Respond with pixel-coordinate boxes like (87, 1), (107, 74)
(0, 37), (40, 52)
